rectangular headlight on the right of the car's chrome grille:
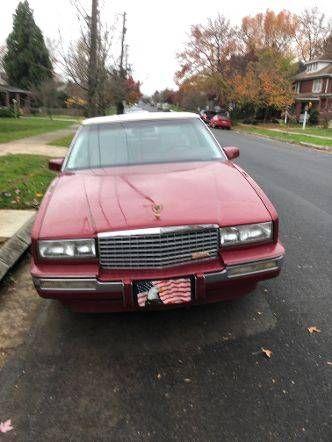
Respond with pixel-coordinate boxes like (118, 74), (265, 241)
(220, 222), (273, 247)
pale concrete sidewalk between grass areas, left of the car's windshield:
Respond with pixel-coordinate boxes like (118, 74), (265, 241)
(0, 127), (75, 157)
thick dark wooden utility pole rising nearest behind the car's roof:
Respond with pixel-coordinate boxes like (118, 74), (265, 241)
(88, 0), (98, 117)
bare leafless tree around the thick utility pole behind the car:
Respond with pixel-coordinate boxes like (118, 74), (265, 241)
(59, 0), (140, 116)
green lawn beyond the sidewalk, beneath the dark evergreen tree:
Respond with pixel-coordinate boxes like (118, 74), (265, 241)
(0, 117), (73, 143)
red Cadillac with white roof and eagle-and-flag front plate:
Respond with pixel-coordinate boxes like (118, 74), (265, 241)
(31, 112), (284, 312)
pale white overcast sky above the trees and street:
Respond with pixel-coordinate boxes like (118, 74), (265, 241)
(0, 0), (332, 94)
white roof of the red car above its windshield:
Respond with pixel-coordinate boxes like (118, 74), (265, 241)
(82, 112), (199, 126)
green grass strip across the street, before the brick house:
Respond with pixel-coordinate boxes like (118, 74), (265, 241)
(238, 125), (332, 149)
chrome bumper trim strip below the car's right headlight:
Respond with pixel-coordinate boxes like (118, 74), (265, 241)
(204, 256), (284, 284)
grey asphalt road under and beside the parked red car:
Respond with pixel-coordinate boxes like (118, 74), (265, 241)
(0, 131), (332, 442)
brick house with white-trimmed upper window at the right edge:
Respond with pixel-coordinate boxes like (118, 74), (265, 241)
(294, 35), (332, 121)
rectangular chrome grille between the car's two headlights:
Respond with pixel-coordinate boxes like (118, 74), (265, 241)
(98, 225), (219, 269)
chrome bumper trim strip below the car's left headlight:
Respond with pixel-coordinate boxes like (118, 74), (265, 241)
(32, 277), (124, 293)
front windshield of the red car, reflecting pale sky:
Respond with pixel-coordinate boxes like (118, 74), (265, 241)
(66, 118), (225, 169)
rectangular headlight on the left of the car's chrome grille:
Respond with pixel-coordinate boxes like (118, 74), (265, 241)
(38, 239), (96, 259)
